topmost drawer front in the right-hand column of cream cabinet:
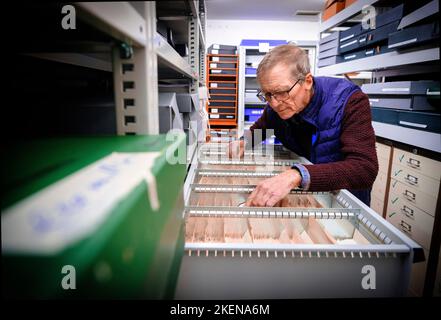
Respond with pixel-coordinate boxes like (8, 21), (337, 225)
(393, 148), (441, 181)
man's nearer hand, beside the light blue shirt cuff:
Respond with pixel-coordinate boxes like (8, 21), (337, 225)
(245, 169), (302, 207)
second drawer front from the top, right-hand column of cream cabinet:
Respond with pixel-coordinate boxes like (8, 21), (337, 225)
(390, 163), (440, 197)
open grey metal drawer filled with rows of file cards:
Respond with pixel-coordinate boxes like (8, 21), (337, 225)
(175, 145), (424, 299)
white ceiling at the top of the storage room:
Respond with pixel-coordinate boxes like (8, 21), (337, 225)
(205, 0), (325, 21)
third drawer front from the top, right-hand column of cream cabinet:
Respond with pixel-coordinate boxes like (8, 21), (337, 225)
(389, 179), (437, 217)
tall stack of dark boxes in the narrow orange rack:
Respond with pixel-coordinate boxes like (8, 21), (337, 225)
(207, 44), (239, 129)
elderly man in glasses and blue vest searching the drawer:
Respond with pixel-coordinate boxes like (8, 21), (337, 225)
(228, 44), (378, 207)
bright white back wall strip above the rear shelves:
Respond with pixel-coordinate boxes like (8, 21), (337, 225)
(206, 20), (319, 47)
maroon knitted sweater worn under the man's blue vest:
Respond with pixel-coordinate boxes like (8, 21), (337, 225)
(250, 91), (378, 191)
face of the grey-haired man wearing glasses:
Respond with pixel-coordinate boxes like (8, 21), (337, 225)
(260, 64), (312, 120)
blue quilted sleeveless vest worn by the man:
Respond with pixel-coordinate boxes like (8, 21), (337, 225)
(267, 77), (370, 205)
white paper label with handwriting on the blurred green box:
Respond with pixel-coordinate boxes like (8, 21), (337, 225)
(2, 152), (160, 255)
